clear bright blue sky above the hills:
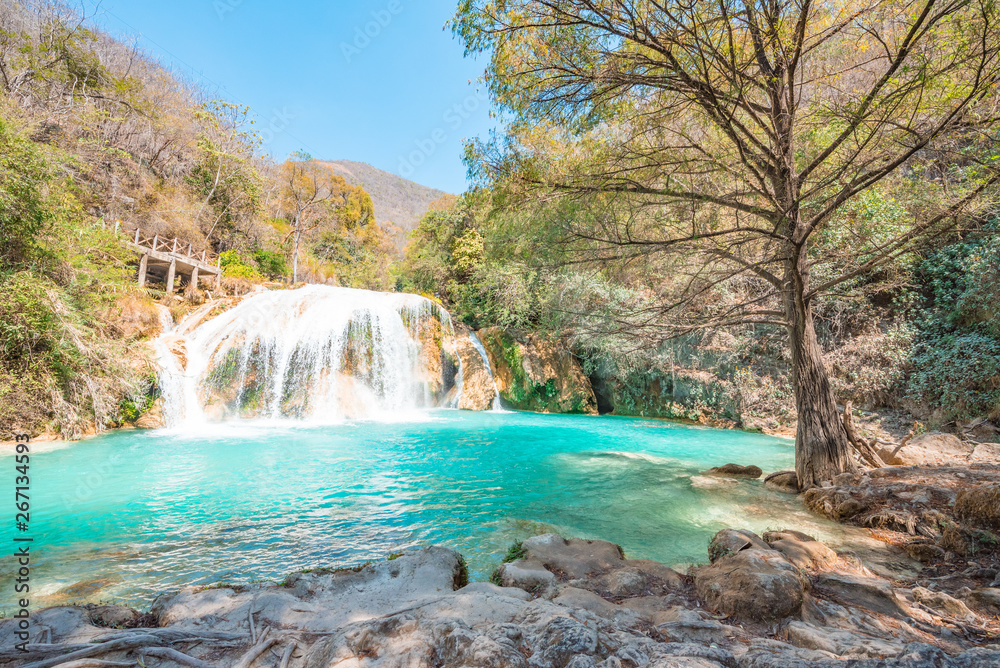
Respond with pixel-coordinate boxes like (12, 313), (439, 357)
(90, 0), (491, 193)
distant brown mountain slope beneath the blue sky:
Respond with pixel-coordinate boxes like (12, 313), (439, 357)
(324, 160), (448, 234)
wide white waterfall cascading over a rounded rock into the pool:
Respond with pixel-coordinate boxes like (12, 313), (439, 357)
(157, 285), (460, 426)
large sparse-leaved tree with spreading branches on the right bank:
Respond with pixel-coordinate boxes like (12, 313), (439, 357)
(453, 0), (1000, 488)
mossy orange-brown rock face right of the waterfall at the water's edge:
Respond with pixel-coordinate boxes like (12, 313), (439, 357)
(478, 327), (597, 414)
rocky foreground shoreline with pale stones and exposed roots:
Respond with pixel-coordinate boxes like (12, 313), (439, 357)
(0, 530), (1000, 668)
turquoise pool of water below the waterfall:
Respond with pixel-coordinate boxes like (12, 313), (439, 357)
(0, 411), (808, 605)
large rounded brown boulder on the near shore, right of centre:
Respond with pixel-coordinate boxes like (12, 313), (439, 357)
(692, 547), (805, 622)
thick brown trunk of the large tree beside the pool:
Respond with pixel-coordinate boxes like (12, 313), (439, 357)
(785, 253), (855, 490)
